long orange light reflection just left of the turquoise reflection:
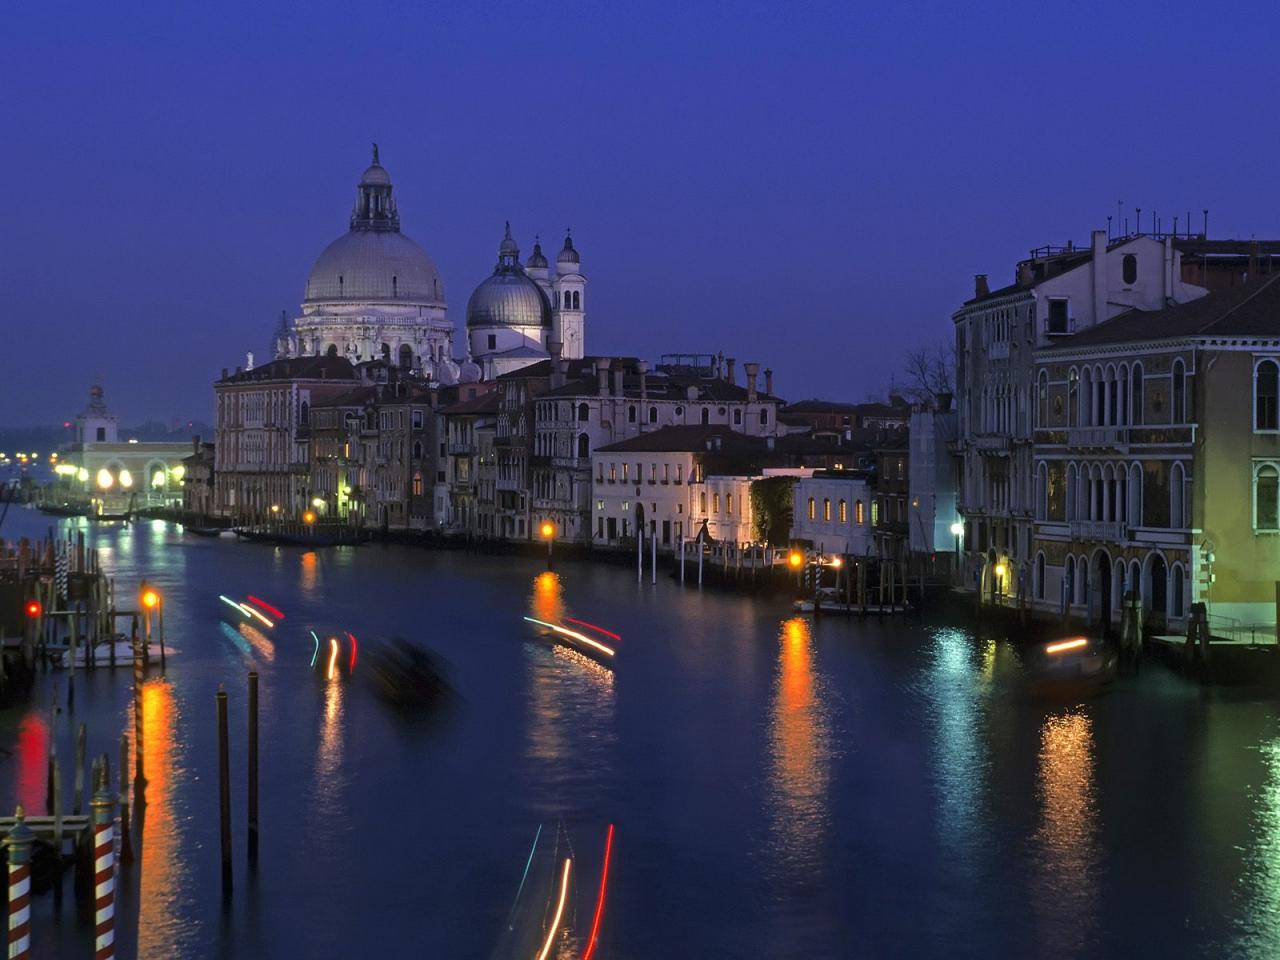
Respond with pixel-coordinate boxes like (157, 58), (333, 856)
(768, 617), (832, 877)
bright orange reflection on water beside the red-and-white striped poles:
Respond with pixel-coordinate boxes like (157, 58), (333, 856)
(135, 680), (198, 957)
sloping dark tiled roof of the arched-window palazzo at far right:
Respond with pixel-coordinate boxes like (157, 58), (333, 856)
(1053, 274), (1280, 349)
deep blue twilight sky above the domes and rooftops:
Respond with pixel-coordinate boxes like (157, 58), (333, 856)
(0, 0), (1280, 426)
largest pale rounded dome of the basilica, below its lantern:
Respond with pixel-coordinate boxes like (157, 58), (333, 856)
(306, 227), (444, 306)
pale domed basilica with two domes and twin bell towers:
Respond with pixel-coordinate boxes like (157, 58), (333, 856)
(273, 146), (586, 385)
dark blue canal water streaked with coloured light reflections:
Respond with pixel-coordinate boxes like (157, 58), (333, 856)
(0, 509), (1280, 960)
